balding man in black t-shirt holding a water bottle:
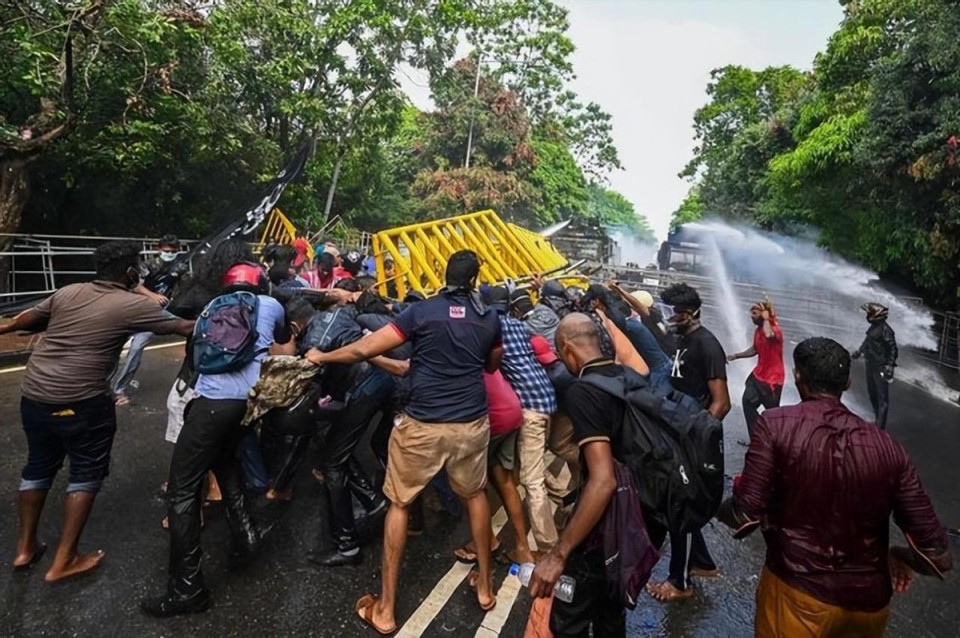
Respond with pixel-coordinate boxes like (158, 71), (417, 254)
(530, 313), (626, 638)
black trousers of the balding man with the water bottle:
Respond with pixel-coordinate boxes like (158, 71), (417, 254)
(550, 549), (627, 638)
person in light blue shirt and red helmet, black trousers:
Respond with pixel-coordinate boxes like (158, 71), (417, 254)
(140, 263), (290, 618)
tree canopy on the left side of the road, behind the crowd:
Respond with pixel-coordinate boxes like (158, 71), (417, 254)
(0, 0), (645, 262)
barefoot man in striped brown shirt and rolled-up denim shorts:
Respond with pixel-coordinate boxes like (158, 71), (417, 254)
(0, 242), (193, 581)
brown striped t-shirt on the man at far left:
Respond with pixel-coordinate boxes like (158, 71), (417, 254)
(21, 281), (181, 404)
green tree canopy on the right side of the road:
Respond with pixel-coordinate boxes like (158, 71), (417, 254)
(674, 0), (960, 306)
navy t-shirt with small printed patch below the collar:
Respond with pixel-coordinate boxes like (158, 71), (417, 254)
(392, 291), (500, 423)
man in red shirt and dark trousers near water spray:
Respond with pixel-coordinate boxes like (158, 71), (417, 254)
(727, 299), (784, 438)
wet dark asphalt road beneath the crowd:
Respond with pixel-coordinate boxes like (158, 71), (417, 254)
(0, 348), (960, 637)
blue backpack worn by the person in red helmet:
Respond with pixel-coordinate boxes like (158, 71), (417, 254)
(190, 291), (267, 374)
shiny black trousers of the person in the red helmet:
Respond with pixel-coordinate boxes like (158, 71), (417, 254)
(167, 397), (254, 598)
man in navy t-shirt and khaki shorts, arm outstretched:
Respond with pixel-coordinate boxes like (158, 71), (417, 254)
(306, 250), (502, 634)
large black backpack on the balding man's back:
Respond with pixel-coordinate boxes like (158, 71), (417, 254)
(582, 370), (723, 533)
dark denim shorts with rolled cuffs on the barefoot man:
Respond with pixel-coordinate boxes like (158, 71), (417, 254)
(20, 395), (117, 492)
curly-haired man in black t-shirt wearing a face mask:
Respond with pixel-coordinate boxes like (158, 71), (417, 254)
(647, 284), (730, 602)
